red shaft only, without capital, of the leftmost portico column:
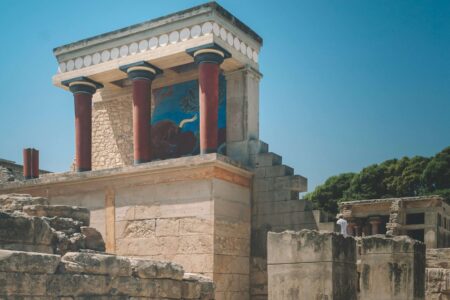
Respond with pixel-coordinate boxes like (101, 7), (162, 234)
(73, 93), (92, 172)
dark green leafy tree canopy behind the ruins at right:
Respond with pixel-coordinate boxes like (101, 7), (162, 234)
(304, 147), (450, 213)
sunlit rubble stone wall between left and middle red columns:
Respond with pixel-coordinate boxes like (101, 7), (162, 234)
(92, 87), (133, 170)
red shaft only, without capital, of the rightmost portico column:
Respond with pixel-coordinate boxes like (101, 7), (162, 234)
(198, 62), (219, 154)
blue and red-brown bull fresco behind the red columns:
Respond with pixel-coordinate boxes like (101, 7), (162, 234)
(151, 75), (226, 159)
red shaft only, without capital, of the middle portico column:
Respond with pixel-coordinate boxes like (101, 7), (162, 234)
(133, 78), (152, 164)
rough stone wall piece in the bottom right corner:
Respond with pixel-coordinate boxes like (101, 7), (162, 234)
(426, 248), (450, 300)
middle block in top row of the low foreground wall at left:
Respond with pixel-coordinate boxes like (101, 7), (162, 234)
(59, 252), (131, 276)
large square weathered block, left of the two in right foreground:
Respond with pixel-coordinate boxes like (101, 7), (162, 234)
(267, 229), (357, 300)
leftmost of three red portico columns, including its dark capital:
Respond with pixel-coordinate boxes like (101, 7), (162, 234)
(62, 77), (103, 172)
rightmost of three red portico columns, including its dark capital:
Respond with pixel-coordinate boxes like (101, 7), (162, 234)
(186, 44), (231, 154)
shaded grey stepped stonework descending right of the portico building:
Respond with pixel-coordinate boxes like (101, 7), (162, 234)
(249, 141), (317, 300)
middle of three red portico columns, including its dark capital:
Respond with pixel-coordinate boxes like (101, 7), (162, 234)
(120, 61), (162, 164)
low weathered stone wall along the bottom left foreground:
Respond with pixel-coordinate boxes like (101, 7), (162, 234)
(0, 250), (214, 300)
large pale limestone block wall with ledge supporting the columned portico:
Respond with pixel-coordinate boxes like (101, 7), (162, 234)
(0, 154), (252, 300)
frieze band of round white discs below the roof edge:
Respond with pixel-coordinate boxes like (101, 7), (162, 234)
(58, 21), (259, 73)
